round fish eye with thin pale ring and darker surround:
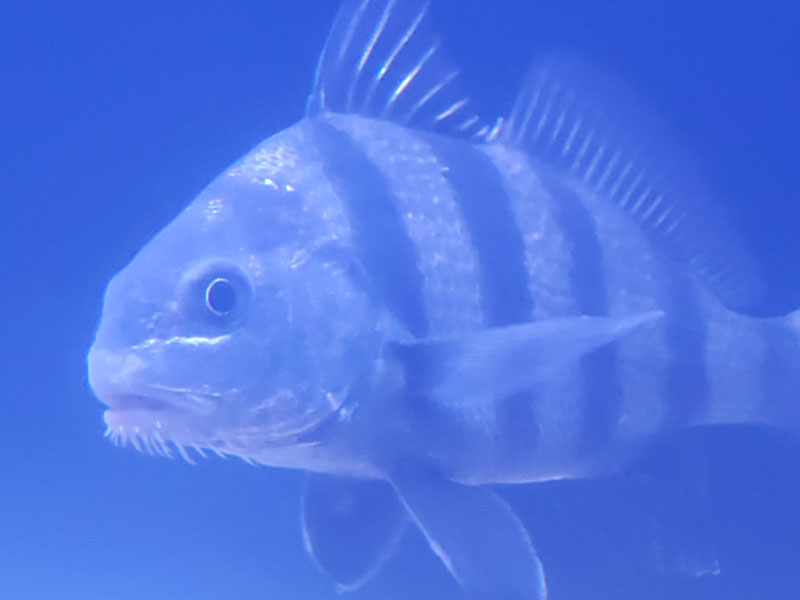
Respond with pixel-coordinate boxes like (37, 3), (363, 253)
(179, 260), (253, 326)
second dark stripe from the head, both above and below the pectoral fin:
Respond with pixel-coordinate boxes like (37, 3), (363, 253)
(418, 135), (538, 463)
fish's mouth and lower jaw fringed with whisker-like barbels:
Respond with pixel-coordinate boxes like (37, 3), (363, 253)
(88, 344), (342, 468)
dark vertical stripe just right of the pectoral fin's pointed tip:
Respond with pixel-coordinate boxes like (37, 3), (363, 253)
(662, 276), (711, 428)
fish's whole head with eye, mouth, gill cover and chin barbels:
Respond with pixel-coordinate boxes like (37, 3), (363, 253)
(88, 129), (384, 462)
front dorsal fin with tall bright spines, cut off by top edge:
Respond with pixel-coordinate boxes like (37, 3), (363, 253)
(306, 0), (486, 137)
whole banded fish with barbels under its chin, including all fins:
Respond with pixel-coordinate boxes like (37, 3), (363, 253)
(87, 0), (800, 600)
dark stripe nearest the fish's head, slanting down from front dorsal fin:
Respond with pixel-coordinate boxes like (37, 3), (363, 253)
(311, 119), (429, 337)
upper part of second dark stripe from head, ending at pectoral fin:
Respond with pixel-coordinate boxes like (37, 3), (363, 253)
(424, 135), (533, 325)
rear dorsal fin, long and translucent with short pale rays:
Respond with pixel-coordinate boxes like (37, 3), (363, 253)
(500, 56), (764, 311)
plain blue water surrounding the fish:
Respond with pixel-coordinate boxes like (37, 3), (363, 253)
(0, 0), (800, 600)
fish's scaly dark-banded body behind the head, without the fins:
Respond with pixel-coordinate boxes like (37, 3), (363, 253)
(229, 114), (800, 483)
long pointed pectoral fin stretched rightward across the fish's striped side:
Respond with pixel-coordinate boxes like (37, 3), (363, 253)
(392, 311), (663, 404)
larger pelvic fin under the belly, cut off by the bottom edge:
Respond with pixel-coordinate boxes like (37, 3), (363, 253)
(390, 465), (547, 600)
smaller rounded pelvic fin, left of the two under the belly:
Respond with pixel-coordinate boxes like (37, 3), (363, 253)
(302, 473), (408, 591)
